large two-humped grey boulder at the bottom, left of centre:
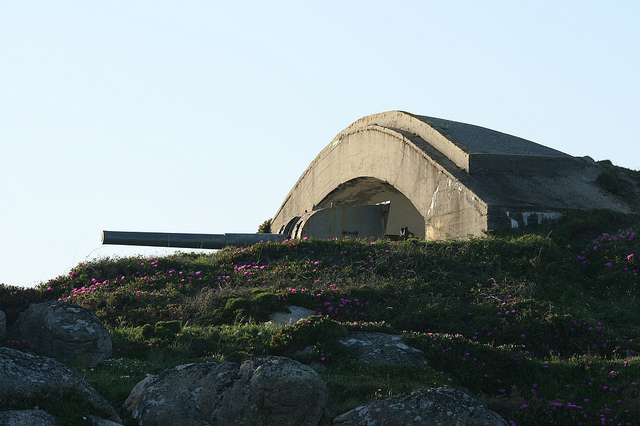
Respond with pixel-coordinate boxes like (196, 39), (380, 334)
(125, 356), (327, 426)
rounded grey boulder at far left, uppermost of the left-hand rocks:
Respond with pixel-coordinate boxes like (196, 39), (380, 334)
(13, 301), (111, 364)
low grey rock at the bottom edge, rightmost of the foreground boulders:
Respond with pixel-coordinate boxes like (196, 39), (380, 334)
(332, 387), (507, 426)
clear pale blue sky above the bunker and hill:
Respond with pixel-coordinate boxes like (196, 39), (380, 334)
(0, 0), (640, 287)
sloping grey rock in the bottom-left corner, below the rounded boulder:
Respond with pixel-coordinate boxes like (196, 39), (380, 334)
(0, 347), (121, 424)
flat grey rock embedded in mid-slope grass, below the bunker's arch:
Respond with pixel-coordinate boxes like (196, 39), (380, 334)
(340, 331), (427, 366)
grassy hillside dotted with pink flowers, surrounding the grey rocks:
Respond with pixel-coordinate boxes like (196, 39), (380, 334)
(0, 212), (640, 425)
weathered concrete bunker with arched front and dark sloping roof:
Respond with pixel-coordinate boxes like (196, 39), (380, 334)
(272, 111), (629, 239)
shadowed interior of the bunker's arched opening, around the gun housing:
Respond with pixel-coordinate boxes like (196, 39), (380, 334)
(314, 177), (425, 238)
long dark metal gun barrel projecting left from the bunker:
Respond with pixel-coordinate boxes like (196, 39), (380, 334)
(102, 231), (286, 249)
